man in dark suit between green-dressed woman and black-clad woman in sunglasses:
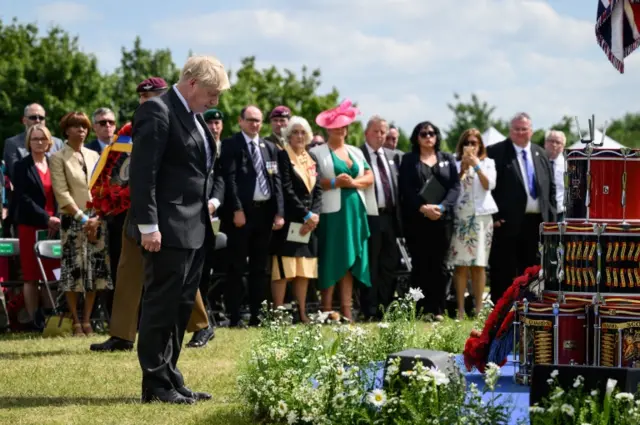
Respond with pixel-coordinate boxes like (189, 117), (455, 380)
(360, 116), (400, 319)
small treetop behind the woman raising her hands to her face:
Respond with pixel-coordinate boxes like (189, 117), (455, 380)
(445, 93), (505, 152)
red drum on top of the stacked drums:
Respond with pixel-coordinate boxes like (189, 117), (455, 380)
(565, 148), (640, 222)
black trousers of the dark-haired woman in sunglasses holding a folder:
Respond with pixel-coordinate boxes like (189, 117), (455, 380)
(404, 217), (453, 315)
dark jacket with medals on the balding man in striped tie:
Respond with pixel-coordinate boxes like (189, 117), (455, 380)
(220, 133), (284, 222)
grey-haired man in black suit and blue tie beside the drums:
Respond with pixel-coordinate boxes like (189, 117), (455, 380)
(487, 113), (556, 303)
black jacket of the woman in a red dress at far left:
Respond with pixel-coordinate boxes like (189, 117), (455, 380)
(14, 155), (58, 227)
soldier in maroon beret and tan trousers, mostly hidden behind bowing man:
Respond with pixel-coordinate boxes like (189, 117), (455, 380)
(90, 77), (212, 351)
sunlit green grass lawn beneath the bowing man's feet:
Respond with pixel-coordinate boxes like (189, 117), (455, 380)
(0, 329), (258, 425)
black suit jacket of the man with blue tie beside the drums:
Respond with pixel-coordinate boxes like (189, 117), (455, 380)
(487, 139), (556, 232)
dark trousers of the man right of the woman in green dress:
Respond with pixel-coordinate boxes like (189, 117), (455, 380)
(360, 209), (400, 318)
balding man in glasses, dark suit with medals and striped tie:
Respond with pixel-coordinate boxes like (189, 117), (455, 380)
(219, 106), (284, 326)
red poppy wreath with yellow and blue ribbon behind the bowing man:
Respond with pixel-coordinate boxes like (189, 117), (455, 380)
(87, 123), (132, 217)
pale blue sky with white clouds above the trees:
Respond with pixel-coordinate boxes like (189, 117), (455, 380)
(0, 0), (640, 136)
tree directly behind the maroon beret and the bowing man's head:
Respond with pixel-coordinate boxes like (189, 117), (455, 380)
(113, 37), (180, 125)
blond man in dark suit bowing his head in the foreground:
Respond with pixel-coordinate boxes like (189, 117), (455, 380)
(129, 56), (230, 404)
